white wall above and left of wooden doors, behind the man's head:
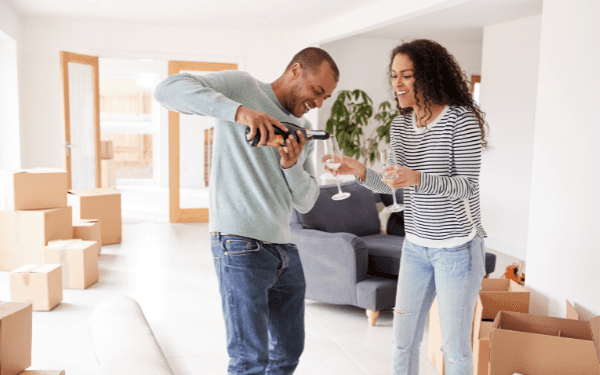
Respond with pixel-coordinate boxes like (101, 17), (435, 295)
(21, 17), (302, 179)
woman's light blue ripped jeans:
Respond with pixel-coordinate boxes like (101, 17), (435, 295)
(392, 237), (485, 375)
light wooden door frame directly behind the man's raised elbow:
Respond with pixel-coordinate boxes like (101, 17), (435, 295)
(169, 61), (238, 223)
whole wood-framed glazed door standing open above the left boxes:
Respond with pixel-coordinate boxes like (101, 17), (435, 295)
(60, 51), (101, 190)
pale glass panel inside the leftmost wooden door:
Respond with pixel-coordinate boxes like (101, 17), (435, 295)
(69, 63), (96, 190)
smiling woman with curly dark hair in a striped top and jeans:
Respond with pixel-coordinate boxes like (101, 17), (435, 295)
(323, 40), (487, 375)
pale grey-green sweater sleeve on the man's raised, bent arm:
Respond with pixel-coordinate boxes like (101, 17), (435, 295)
(154, 71), (241, 122)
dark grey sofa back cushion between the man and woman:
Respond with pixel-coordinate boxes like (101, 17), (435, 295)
(291, 181), (380, 237)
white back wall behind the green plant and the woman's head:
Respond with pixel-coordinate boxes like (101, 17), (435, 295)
(317, 36), (481, 181)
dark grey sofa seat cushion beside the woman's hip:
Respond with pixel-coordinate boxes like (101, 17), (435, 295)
(361, 234), (404, 277)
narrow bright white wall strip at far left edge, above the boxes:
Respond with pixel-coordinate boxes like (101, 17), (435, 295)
(0, 0), (23, 170)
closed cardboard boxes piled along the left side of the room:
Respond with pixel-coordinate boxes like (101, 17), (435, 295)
(0, 168), (121, 375)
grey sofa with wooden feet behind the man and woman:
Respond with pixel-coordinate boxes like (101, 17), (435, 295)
(290, 181), (495, 325)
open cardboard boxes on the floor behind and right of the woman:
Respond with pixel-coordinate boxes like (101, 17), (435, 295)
(428, 279), (600, 375)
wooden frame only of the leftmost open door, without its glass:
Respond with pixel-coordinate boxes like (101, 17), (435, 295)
(60, 51), (102, 190)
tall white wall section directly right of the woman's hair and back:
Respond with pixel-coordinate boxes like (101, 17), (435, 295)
(480, 15), (542, 260)
